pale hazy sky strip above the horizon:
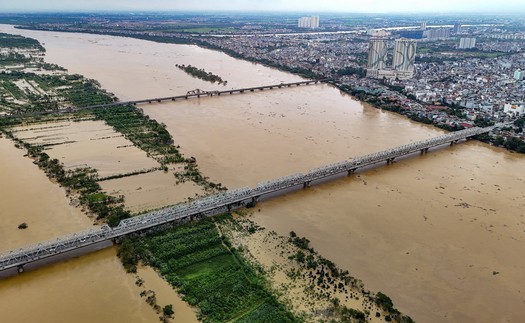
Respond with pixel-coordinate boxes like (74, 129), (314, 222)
(0, 0), (525, 13)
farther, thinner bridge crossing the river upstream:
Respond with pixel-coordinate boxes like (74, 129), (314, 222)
(1, 80), (324, 118)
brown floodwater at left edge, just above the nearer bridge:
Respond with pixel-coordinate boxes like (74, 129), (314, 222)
(0, 134), (93, 253)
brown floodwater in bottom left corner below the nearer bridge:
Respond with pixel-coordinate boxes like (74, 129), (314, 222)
(0, 248), (195, 323)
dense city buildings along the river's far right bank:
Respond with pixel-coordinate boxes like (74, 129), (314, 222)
(2, 12), (525, 146)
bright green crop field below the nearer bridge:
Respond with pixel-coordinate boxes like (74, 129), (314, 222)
(118, 216), (298, 322)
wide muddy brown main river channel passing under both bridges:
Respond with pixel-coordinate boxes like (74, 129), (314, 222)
(0, 26), (525, 322)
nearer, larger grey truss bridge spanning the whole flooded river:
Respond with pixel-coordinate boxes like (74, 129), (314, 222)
(0, 127), (495, 276)
